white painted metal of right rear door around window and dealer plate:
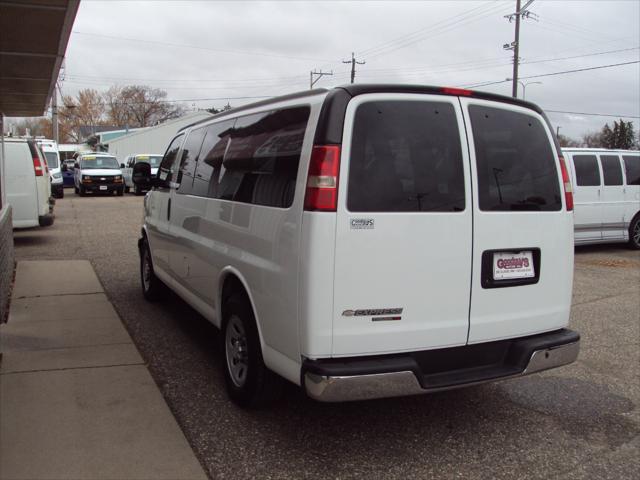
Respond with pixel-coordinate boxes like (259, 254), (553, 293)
(461, 99), (573, 344)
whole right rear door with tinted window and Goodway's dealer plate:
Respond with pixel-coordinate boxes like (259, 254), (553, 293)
(461, 98), (573, 343)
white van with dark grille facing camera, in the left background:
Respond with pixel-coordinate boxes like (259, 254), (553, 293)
(73, 153), (124, 196)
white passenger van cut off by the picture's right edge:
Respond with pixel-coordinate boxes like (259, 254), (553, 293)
(562, 148), (640, 249)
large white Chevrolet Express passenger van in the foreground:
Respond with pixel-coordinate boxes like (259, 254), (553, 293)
(133, 85), (580, 406)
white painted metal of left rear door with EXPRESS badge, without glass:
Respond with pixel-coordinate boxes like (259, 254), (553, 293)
(333, 93), (472, 356)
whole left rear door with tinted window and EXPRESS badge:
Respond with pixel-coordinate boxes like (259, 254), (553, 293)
(333, 93), (472, 356)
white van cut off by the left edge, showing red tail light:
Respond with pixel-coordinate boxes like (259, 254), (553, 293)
(4, 137), (54, 228)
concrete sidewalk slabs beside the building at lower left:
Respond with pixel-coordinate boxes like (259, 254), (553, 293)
(0, 260), (207, 480)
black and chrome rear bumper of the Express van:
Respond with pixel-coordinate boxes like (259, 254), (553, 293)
(302, 329), (580, 402)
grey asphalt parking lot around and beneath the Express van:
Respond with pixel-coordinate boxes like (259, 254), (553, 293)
(14, 189), (640, 479)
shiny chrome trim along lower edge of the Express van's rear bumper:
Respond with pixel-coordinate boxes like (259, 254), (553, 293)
(304, 342), (580, 402)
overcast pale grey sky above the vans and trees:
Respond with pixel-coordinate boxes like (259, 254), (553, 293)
(56, 0), (640, 138)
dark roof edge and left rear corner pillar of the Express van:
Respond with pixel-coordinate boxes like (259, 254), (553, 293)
(178, 83), (544, 143)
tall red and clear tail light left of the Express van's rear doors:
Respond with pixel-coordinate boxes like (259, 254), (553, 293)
(304, 145), (340, 212)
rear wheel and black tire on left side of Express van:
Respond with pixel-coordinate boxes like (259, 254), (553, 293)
(221, 294), (283, 408)
